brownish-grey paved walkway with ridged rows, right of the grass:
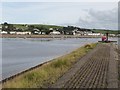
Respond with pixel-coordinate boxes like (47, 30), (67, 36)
(51, 44), (118, 88)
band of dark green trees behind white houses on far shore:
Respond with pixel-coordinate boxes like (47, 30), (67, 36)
(2, 22), (91, 35)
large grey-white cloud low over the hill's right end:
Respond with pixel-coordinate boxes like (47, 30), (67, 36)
(76, 8), (118, 30)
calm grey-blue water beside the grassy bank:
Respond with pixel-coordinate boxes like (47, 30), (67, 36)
(0, 38), (117, 79)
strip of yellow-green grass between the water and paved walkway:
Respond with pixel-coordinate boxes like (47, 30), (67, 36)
(3, 43), (97, 88)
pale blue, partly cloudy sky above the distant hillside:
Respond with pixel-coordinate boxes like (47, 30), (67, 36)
(0, 2), (118, 30)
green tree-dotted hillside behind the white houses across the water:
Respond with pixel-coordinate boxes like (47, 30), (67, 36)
(2, 22), (120, 35)
